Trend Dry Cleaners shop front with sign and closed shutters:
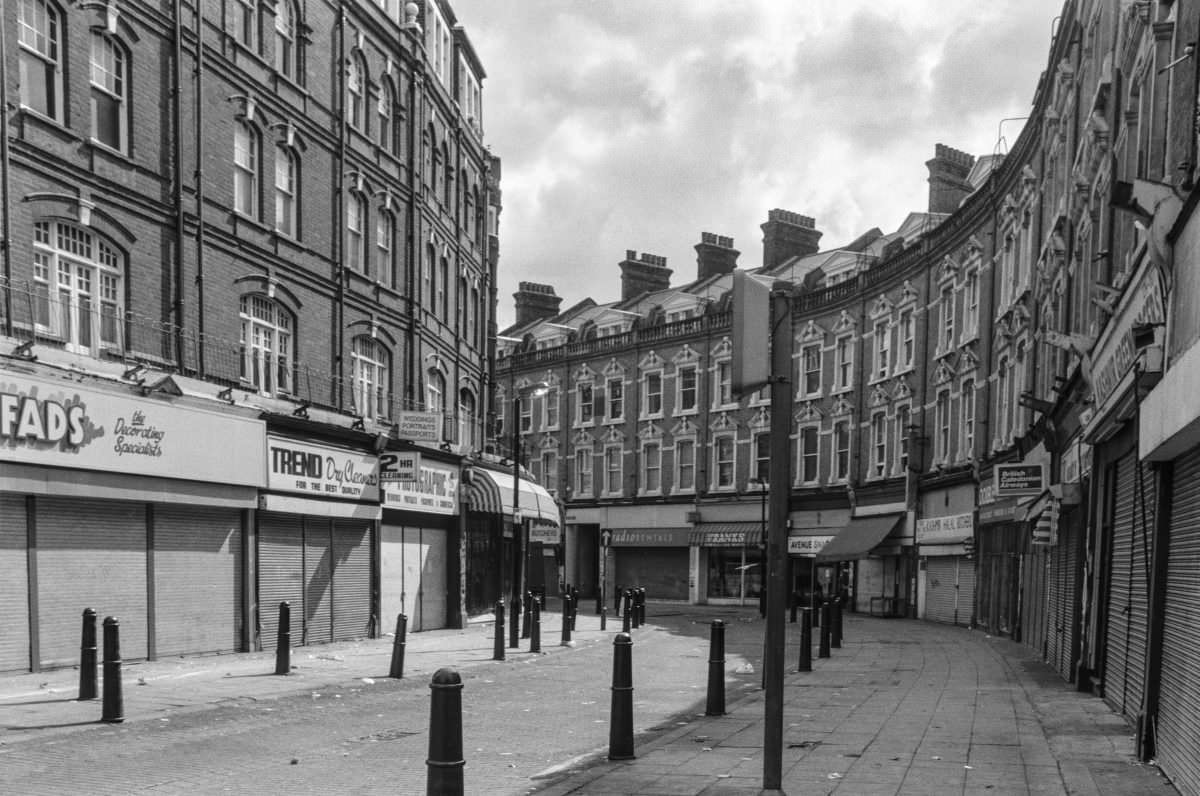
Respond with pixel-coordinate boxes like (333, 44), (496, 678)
(256, 431), (383, 650)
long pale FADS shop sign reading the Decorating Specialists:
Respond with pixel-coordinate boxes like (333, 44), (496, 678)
(0, 373), (266, 486)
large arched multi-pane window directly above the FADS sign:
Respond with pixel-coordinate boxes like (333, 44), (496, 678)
(34, 221), (125, 353)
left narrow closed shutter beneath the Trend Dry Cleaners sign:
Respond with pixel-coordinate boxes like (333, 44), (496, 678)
(258, 511), (304, 650)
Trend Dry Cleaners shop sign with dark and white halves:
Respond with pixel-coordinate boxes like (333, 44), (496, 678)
(266, 433), (379, 503)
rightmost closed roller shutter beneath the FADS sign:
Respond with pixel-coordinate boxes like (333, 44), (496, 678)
(154, 505), (241, 656)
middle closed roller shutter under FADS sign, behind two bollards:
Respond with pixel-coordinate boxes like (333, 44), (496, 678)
(36, 497), (149, 668)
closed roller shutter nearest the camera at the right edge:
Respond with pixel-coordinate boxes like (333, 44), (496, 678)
(1157, 449), (1200, 792)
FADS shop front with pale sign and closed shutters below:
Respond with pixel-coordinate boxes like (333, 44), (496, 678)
(0, 363), (265, 671)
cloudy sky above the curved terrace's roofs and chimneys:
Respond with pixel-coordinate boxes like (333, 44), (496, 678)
(451, 0), (1061, 329)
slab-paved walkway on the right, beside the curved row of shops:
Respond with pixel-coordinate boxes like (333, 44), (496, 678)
(538, 615), (1176, 796)
